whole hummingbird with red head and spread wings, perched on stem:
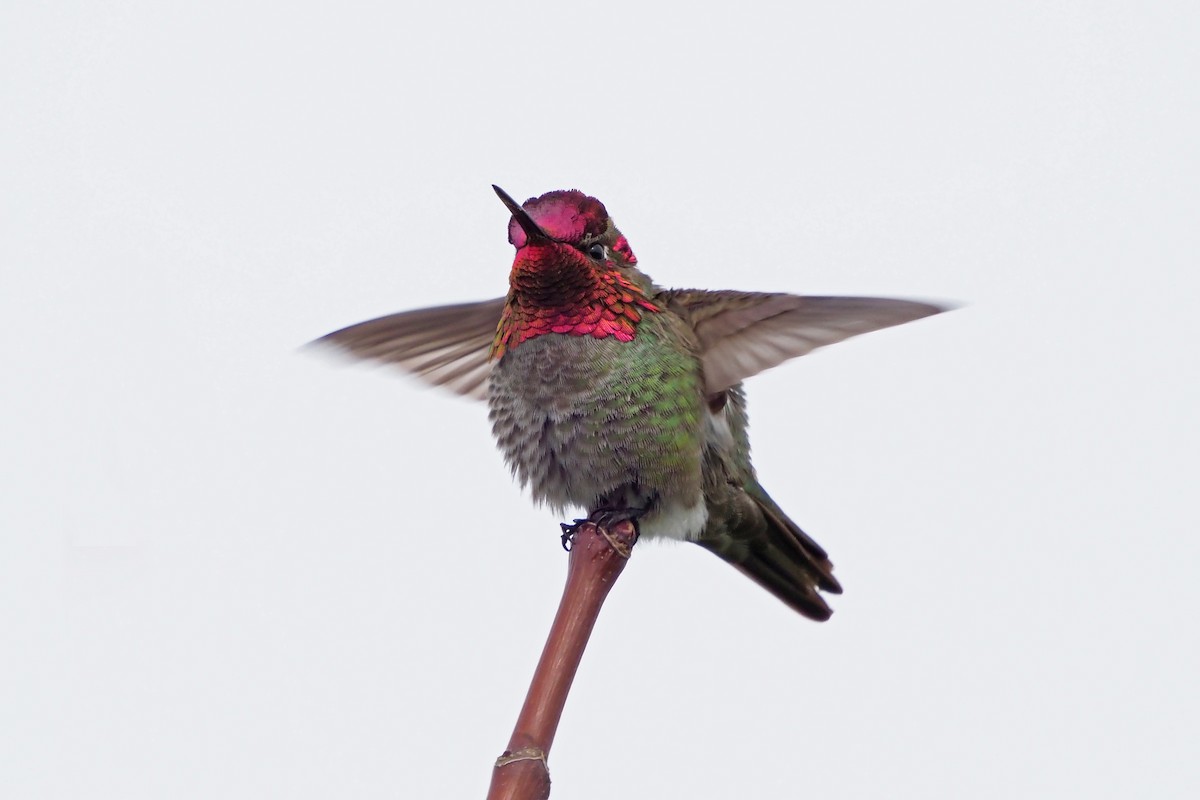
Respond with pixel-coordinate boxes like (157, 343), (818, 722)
(319, 186), (944, 620)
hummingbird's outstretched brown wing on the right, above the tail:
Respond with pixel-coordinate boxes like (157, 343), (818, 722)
(661, 289), (947, 395)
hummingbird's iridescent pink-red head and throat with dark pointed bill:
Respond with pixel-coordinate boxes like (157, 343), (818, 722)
(492, 186), (658, 357)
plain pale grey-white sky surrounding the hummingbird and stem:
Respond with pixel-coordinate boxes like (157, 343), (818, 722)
(0, 1), (1200, 799)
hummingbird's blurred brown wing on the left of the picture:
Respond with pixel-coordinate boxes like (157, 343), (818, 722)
(313, 297), (505, 399)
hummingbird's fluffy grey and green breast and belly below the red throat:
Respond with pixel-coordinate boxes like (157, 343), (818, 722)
(488, 335), (706, 539)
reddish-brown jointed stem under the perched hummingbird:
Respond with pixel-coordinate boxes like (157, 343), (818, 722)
(487, 522), (637, 800)
